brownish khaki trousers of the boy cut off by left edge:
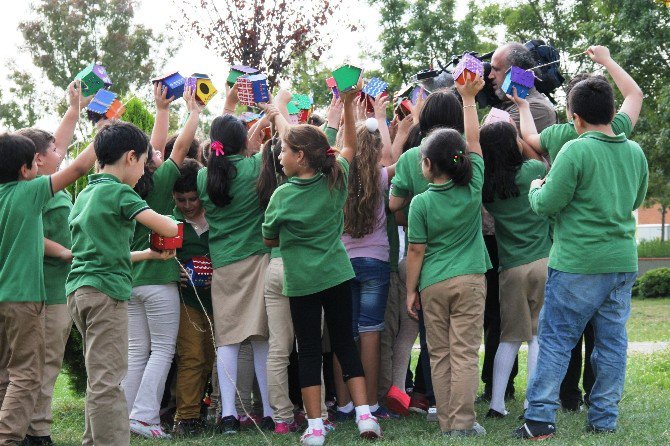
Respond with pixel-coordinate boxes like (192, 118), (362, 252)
(0, 302), (44, 445)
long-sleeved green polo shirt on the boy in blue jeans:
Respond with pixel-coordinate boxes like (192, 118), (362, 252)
(528, 132), (648, 274)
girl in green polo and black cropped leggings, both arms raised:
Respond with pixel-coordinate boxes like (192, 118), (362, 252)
(263, 92), (381, 445)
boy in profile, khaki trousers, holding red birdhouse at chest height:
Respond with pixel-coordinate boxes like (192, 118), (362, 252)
(65, 122), (177, 445)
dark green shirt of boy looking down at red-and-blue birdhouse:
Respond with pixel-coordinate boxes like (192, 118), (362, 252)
(173, 208), (212, 314)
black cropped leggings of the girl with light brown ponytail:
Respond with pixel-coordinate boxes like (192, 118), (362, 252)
(289, 281), (365, 388)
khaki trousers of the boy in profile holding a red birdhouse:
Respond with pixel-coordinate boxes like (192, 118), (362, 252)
(67, 286), (130, 446)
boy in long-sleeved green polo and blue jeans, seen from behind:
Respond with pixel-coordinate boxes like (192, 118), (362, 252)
(515, 78), (648, 439)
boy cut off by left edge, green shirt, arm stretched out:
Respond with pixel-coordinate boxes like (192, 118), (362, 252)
(0, 123), (95, 444)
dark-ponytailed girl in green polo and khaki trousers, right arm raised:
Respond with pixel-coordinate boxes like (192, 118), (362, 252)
(406, 76), (491, 436)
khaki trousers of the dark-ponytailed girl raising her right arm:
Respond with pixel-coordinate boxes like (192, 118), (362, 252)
(421, 274), (486, 432)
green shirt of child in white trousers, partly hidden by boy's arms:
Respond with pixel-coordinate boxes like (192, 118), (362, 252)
(130, 159), (181, 287)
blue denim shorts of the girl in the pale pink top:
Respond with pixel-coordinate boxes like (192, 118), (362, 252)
(351, 257), (391, 339)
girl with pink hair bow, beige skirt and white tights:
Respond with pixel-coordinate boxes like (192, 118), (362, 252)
(198, 115), (274, 433)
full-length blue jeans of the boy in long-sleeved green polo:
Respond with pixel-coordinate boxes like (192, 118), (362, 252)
(525, 268), (637, 429)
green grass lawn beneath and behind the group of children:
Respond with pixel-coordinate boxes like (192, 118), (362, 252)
(52, 299), (670, 446)
